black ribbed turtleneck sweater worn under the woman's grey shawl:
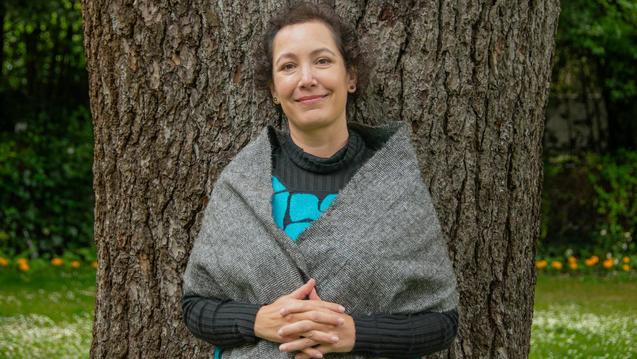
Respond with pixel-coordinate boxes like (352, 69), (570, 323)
(182, 125), (458, 358)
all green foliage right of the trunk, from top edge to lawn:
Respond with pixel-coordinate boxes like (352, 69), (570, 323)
(539, 0), (637, 256)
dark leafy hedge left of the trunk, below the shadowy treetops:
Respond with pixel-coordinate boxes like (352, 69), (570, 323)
(0, 107), (94, 257)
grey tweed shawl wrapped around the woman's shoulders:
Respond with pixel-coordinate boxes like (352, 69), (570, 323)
(183, 121), (458, 359)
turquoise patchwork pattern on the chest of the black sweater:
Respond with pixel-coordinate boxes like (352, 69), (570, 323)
(272, 176), (336, 241)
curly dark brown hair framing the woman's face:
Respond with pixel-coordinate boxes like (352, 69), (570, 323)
(254, 2), (367, 101)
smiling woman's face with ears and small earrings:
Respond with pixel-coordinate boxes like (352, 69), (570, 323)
(271, 21), (356, 134)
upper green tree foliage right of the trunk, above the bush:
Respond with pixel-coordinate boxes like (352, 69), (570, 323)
(548, 0), (637, 152)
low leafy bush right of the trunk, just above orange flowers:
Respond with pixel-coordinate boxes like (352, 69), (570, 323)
(540, 150), (637, 255)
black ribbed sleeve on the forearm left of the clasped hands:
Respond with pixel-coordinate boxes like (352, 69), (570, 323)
(181, 295), (261, 348)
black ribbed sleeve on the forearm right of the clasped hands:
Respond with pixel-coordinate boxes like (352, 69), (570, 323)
(352, 308), (458, 358)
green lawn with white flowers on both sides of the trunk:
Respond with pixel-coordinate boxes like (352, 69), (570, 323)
(0, 268), (637, 358)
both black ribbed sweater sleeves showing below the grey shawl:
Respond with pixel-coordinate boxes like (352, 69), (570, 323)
(182, 295), (458, 358)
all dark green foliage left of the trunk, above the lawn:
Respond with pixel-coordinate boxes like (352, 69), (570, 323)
(0, 0), (93, 257)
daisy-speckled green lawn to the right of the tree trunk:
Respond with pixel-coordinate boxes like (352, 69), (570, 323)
(530, 273), (637, 358)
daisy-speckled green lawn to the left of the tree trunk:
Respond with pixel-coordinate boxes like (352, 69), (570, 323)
(0, 268), (95, 358)
